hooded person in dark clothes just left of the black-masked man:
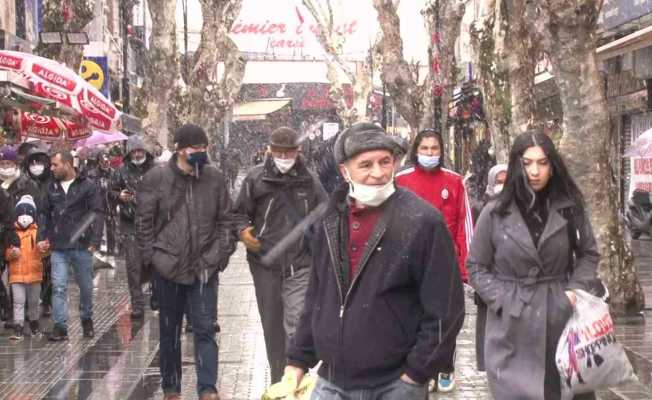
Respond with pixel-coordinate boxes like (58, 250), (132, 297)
(109, 135), (154, 319)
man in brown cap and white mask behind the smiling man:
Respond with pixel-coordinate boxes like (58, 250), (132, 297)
(236, 127), (326, 382)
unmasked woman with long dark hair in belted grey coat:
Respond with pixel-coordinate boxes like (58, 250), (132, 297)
(467, 131), (599, 400)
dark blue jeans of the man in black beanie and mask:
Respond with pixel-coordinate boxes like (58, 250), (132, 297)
(153, 272), (218, 394)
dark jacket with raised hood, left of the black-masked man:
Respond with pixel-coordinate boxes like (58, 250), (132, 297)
(108, 135), (154, 227)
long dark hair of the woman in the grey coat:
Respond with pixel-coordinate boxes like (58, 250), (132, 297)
(496, 129), (584, 215)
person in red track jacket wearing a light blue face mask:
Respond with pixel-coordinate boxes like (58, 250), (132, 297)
(396, 129), (473, 392)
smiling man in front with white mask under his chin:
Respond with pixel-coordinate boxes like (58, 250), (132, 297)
(286, 123), (464, 400)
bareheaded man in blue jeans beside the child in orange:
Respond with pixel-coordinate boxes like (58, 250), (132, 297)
(38, 151), (104, 341)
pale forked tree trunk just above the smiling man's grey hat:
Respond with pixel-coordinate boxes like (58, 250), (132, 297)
(303, 0), (373, 126)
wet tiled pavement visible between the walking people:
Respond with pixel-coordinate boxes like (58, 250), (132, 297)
(0, 239), (652, 400)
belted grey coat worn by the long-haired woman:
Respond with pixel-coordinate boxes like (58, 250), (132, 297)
(467, 200), (600, 400)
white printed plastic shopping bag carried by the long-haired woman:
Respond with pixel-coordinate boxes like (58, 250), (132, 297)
(556, 290), (636, 399)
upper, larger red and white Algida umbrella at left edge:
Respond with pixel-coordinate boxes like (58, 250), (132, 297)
(0, 50), (122, 140)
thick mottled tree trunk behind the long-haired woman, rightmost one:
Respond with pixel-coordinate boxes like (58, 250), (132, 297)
(544, 0), (644, 314)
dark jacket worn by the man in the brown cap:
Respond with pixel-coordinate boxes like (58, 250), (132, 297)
(235, 157), (326, 271)
